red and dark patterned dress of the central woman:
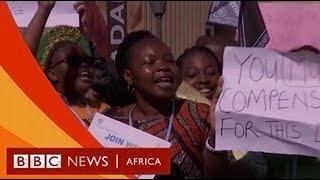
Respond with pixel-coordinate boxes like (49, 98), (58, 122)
(104, 99), (210, 178)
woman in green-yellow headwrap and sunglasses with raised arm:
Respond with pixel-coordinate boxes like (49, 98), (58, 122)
(23, 1), (109, 127)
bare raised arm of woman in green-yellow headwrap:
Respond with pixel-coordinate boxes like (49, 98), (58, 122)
(23, 1), (55, 57)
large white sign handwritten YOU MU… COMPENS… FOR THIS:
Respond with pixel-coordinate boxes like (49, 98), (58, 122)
(215, 47), (320, 156)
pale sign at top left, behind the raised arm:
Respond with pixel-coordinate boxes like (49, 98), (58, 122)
(7, 1), (79, 27)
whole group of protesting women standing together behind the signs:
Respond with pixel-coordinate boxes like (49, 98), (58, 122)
(23, 1), (318, 178)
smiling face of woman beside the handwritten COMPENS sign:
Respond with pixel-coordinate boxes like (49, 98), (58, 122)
(181, 52), (219, 100)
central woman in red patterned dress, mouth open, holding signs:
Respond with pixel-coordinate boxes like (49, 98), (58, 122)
(105, 31), (229, 178)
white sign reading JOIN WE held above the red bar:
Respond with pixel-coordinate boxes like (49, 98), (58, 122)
(89, 113), (171, 148)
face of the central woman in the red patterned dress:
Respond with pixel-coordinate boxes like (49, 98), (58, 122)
(124, 39), (181, 101)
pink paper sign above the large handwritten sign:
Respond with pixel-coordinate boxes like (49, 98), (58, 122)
(258, 1), (320, 51)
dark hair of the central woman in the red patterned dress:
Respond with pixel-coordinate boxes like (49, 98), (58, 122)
(115, 30), (158, 81)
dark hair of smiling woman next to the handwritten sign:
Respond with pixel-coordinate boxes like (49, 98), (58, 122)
(177, 46), (222, 75)
